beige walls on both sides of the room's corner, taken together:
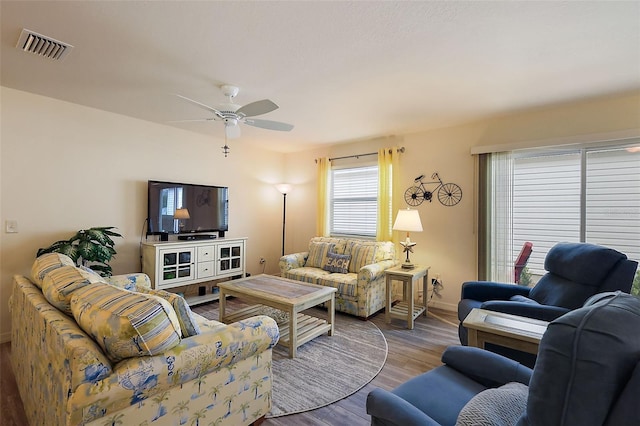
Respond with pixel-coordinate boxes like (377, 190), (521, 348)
(0, 88), (640, 341)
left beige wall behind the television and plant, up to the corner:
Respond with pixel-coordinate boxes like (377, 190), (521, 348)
(0, 87), (284, 341)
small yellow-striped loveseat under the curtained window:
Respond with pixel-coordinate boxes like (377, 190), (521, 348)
(279, 237), (399, 318)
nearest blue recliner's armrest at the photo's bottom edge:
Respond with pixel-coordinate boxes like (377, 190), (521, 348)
(367, 388), (439, 426)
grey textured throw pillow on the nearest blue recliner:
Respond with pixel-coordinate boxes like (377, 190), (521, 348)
(456, 382), (529, 426)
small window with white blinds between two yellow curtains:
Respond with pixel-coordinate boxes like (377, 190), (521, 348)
(329, 165), (378, 238)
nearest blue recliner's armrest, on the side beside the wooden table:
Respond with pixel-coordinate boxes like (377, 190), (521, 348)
(442, 346), (533, 387)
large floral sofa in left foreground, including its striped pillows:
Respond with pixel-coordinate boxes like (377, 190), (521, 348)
(9, 253), (279, 426)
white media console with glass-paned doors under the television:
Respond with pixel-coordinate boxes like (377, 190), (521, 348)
(142, 237), (247, 305)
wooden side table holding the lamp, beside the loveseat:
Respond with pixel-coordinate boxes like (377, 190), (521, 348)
(384, 265), (429, 330)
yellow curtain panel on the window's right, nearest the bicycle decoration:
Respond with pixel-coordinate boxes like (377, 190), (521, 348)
(376, 146), (400, 241)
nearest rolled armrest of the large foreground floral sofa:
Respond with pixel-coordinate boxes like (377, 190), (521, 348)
(70, 315), (280, 406)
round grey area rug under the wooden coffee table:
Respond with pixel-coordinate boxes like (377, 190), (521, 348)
(193, 303), (388, 418)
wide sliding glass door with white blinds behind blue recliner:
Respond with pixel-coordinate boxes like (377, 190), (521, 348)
(480, 141), (640, 282)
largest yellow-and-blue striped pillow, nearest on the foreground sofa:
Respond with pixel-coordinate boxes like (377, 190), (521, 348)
(71, 283), (182, 363)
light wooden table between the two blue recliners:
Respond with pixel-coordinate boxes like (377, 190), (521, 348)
(462, 308), (549, 355)
